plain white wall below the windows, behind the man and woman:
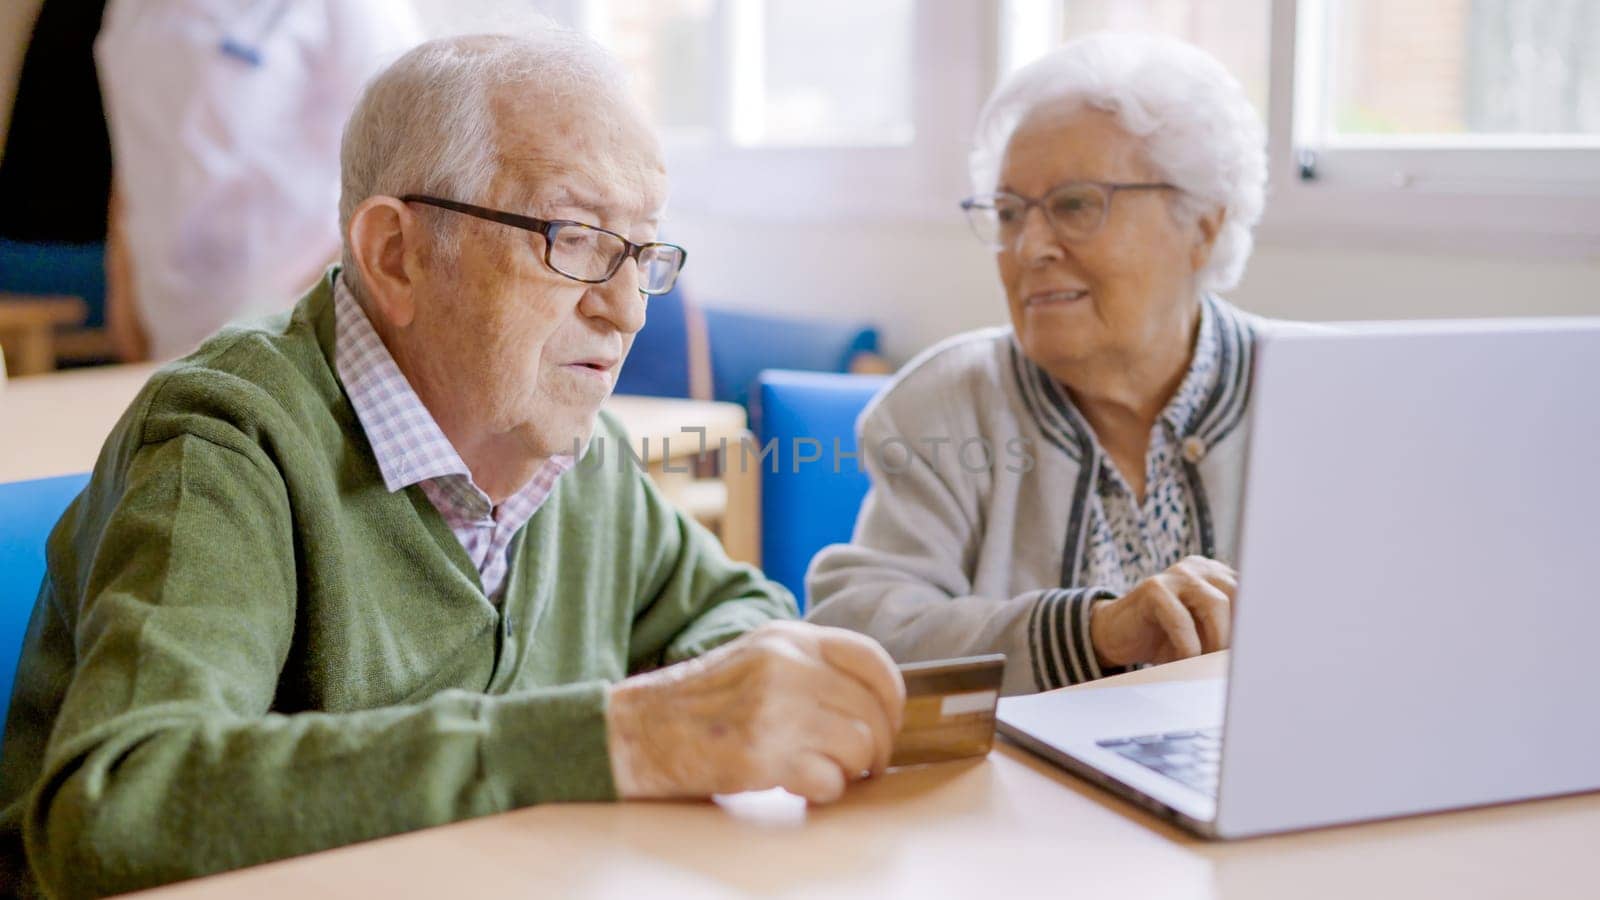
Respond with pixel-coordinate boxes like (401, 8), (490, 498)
(667, 211), (1600, 360)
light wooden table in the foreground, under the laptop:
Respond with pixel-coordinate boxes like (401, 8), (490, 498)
(128, 653), (1600, 900)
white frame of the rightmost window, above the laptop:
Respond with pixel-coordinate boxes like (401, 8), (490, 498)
(1258, 0), (1600, 258)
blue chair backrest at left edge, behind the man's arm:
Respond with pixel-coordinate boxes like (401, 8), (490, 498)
(0, 472), (90, 727)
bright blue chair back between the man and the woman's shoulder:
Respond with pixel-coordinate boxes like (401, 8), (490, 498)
(750, 370), (890, 612)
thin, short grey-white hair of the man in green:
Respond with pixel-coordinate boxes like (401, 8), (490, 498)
(339, 24), (627, 296)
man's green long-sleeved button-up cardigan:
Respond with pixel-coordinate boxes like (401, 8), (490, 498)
(0, 279), (795, 895)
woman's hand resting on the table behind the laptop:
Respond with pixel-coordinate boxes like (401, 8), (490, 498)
(1090, 556), (1238, 666)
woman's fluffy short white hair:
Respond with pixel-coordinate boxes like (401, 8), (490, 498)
(970, 34), (1267, 291)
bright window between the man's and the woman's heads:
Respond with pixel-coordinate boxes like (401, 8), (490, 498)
(569, 0), (994, 223)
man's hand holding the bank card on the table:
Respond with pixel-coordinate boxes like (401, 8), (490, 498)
(606, 621), (906, 802)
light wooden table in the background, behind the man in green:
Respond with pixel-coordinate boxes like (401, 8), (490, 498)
(0, 364), (762, 564)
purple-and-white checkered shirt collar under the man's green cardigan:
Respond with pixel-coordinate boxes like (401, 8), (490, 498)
(333, 279), (573, 602)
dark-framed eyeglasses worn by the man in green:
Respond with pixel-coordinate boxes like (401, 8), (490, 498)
(400, 194), (690, 295)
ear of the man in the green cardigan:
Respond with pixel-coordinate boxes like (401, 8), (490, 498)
(349, 195), (424, 328)
